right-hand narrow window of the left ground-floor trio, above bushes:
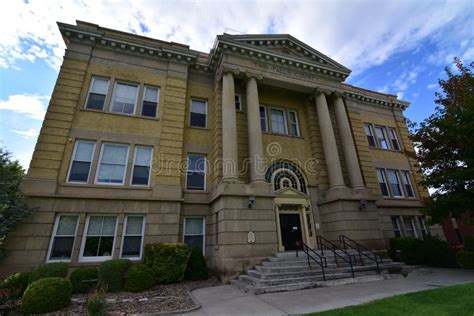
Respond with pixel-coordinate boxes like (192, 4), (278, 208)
(120, 215), (145, 259)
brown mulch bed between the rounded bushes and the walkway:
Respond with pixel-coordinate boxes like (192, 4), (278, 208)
(58, 278), (221, 315)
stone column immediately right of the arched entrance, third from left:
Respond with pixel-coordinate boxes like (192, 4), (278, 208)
(315, 92), (345, 188)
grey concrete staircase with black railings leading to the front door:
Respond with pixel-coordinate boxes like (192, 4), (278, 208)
(232, 250), (404, 294)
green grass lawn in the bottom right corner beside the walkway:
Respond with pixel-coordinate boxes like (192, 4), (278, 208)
(310, 283), (474, 316)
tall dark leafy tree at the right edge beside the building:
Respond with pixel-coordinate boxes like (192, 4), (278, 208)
(412, 58), (474, 223)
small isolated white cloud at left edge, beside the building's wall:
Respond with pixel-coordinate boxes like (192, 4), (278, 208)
(0, 94), (49, 120)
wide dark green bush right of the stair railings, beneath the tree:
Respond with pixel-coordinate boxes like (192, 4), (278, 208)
(390, 235), (456, 267)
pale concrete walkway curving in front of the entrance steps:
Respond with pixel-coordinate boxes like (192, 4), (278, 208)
(181, 268), (474, 316)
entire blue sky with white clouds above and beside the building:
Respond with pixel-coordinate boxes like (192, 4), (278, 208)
(0, 0), (474, 169)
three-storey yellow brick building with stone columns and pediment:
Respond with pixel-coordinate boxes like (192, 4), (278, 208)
(0, 22), (442, 278)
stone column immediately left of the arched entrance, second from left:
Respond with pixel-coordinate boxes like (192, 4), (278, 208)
(247, 77), (265, 182)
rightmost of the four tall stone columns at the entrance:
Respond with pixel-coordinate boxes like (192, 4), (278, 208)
(334, 95), (364, 188)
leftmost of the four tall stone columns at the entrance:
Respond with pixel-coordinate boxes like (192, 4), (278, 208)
(222, 72), (238, 180)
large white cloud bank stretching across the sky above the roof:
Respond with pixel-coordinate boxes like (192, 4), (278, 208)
(0, 0), (472, 72)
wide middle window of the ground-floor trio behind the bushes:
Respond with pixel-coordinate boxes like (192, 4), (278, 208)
(81, 215), (117, 261)
